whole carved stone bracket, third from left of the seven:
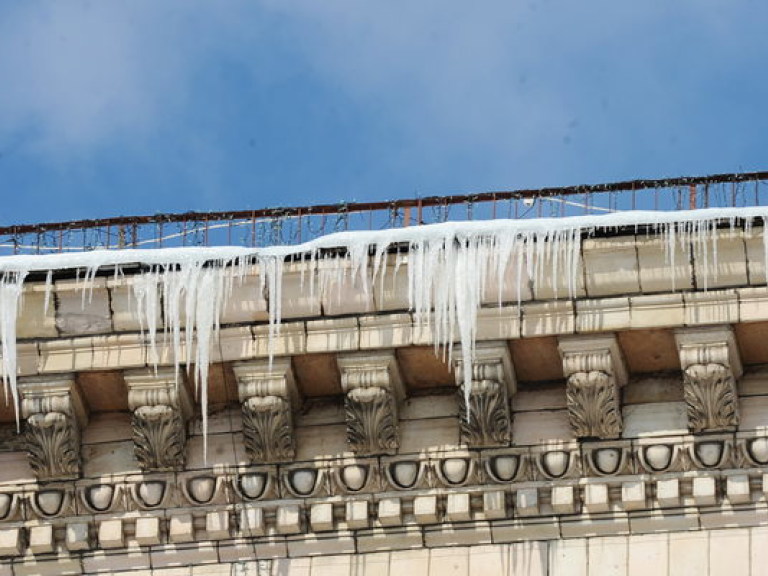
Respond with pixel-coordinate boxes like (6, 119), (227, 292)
(234, 358), (298, 464)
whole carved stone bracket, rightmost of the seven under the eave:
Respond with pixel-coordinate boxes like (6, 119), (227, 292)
(675, 327), (743, 432)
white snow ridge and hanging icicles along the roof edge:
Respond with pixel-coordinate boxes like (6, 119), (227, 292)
(0, 207), (768, 450)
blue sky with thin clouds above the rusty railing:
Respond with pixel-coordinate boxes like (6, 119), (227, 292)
(0, 0), (768, 224)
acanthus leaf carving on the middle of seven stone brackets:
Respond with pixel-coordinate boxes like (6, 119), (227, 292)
(345, 386), (399, 455)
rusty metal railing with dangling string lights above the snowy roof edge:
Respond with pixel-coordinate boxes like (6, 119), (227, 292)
(0, 172), (768, 255)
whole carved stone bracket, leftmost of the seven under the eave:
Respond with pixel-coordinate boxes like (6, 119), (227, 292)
(19, 376), (87, 480)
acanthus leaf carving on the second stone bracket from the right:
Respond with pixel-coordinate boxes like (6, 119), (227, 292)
(566, 370), (622, 438)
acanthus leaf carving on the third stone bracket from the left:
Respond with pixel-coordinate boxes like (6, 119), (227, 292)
(243, 396), (295, 463)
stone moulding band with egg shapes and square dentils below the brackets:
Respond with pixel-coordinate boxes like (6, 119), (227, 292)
(0, 433), (768, 559)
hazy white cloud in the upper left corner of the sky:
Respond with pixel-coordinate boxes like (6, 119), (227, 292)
(0, 0), (252, 155)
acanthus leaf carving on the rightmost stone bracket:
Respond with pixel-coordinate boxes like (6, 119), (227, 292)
(683, 363), (739, 432)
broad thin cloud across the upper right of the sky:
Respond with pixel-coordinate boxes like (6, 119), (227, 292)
(258, 0), (765, 180)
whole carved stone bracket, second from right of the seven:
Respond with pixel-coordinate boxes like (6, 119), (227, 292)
(558, 335), (627, 439)
